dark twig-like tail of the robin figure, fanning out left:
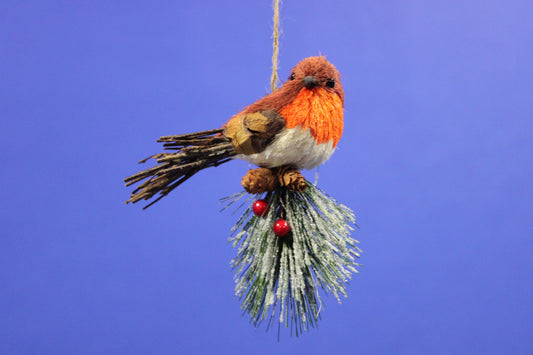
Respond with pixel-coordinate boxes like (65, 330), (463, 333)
(124, 128), (237, 209)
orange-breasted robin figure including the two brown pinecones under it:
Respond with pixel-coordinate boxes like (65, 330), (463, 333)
(125, 56), (344, 208)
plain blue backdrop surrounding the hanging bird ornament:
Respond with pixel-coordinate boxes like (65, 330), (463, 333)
(0, 0), (533, 354)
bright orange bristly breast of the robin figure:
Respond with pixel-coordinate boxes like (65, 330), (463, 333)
(280, 88), (344, 147)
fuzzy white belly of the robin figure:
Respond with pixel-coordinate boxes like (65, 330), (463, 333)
(237, 127), (335, 169)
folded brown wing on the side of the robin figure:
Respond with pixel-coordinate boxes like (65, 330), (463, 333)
(224, 110), (285, 155)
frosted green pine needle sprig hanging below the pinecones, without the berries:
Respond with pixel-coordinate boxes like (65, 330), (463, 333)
(224, 182), (361, 336)
